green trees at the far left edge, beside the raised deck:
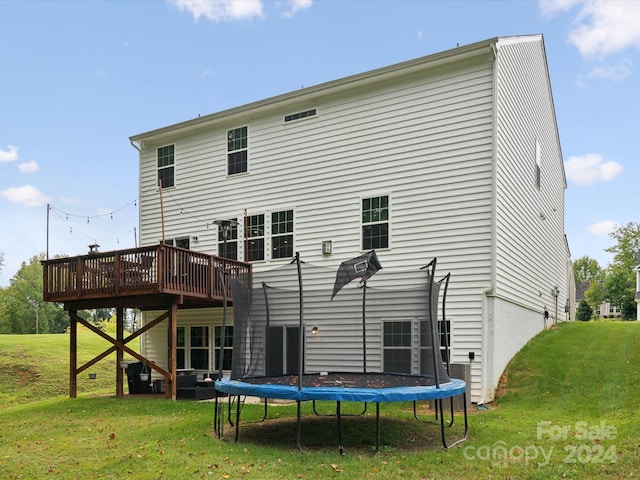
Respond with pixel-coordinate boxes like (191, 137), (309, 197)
(0, 254), (69, 333)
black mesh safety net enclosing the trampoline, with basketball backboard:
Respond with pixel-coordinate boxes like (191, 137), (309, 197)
(225, 252), (449, 386)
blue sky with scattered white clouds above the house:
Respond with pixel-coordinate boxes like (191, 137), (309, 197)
(0, 0), (640, 287)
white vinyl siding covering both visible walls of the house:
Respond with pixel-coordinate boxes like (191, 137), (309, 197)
(134, 37), (567, 401)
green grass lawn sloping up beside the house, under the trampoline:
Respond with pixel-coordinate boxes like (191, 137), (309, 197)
(0, 322), (640, 479)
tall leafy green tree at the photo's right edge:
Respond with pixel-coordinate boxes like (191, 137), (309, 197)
(604, 222), (640, 320)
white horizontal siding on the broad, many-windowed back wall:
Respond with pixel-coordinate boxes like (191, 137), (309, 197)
(136, 54), (493, 400)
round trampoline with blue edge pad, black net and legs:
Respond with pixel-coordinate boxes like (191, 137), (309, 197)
(214, 252), (468, 454)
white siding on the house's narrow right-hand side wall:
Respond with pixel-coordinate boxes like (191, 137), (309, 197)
(487, 37), (568, 398)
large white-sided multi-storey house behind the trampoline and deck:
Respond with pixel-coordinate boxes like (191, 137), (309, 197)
(130, 35), (575, 403)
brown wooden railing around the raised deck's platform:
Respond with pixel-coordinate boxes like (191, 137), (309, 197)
(42, 245), (251, 302)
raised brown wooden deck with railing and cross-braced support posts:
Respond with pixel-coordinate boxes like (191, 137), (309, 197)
(42, 245), (251, 400)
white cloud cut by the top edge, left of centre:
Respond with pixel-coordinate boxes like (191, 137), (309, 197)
(169, 0), (263, 22)
